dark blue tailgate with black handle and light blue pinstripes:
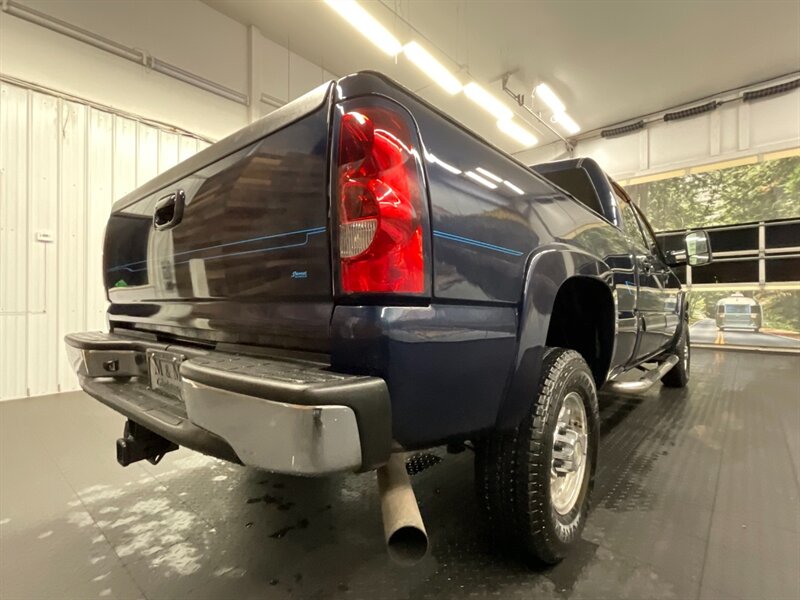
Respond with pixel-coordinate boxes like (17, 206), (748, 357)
(104, 84), (333, 352)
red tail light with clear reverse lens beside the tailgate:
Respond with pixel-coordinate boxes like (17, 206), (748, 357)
(335, 105), (426, 294)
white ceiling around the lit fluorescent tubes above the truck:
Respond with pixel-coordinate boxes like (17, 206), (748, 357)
(205, 0), (800, 152)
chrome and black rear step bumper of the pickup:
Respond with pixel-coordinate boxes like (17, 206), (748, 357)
(65, 332), (391, 475)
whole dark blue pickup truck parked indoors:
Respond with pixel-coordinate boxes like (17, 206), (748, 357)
(66, 72), (711, 563)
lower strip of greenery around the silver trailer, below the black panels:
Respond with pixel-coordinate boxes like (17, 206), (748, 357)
(689, 290), (800, 333)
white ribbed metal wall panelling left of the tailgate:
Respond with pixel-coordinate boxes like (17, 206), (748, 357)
(0, 83), (207, 400)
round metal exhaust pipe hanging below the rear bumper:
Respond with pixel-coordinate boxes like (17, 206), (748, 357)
(378, 453), (428, 565)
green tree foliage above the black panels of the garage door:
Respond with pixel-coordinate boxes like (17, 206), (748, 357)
(625, 156), (800, 231)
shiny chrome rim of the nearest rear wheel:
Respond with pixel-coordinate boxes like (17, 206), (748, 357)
(550, 392), (587, 515)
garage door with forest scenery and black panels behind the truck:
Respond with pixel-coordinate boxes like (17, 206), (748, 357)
(627, 150), (800, 352)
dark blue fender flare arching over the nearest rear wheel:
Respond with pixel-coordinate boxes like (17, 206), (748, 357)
(496, 244), (616, 429)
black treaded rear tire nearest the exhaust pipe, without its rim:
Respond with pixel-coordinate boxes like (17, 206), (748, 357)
(475, 348), (600, 564)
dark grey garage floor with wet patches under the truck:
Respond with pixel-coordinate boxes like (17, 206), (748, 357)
(0, 350), (800, 600)
